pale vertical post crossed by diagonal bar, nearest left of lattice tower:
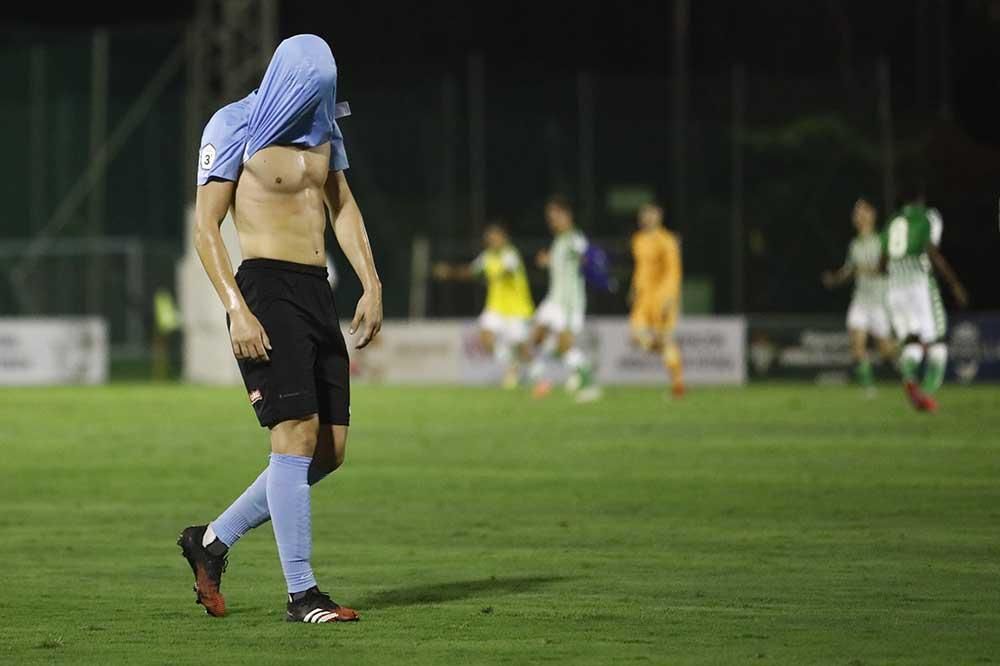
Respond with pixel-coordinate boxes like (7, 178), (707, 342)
(86, 28), (108, 314)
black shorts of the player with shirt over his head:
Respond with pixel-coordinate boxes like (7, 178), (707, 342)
(226, 259), (351, 428)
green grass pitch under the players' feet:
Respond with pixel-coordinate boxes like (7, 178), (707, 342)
(0, 385), (1000, 666)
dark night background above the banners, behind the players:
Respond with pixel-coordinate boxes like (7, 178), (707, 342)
(0, 0), (1000, 322)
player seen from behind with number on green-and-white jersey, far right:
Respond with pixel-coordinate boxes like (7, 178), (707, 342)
(881, 197), (968, 412)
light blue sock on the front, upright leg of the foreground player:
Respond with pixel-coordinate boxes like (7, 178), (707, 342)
(267, 453), (316, 594)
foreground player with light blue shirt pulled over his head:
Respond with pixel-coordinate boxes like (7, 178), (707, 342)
(178, 35), (382, 623)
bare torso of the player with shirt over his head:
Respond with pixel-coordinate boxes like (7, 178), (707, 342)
(233, 143), (330, 266)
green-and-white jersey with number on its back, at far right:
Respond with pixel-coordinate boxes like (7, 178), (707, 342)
(882, 204), (944, 289)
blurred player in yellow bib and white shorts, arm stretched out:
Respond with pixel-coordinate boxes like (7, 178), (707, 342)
(434, 223), (535, 388)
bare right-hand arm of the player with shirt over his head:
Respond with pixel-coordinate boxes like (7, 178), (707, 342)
(323, 171), (382, 349)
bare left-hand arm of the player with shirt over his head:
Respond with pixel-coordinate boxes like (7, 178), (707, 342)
(194, 180), (271, 361)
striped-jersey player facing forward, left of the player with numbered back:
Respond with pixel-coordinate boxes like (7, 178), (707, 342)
(822, 199), (896, 389)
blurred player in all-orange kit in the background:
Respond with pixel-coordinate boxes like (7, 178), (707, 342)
(629, 204), (684, 398)
